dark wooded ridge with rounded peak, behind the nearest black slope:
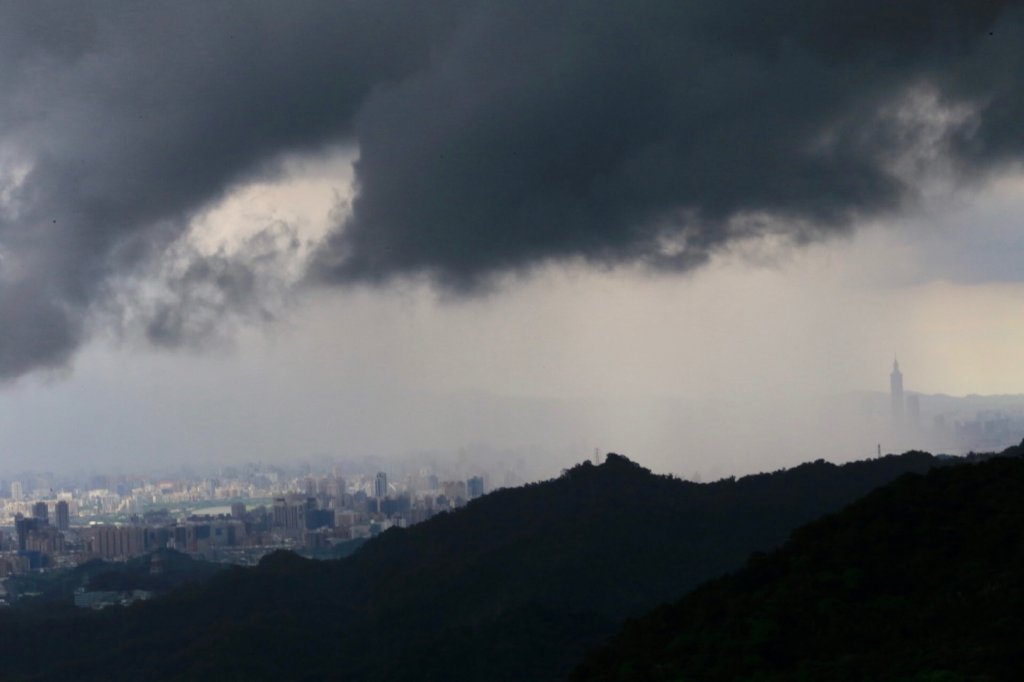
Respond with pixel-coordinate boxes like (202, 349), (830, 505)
(0, 453), (935, 681)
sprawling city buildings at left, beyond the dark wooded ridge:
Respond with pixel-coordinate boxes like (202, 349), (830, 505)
(0, 456), (509, 604)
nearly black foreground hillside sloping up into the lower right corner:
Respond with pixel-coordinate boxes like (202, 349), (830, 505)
(572, 449), (1024, 682)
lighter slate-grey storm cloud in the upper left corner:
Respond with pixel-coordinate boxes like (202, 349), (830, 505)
(0, 2), (468, 378)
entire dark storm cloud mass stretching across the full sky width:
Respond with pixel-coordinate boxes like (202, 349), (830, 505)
(0, 0), (1024, 377)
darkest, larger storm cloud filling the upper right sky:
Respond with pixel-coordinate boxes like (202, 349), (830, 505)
(324, 1), (1024, 287)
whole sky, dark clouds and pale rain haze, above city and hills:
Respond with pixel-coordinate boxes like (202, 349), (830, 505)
(0, 0), (1024, 476)
